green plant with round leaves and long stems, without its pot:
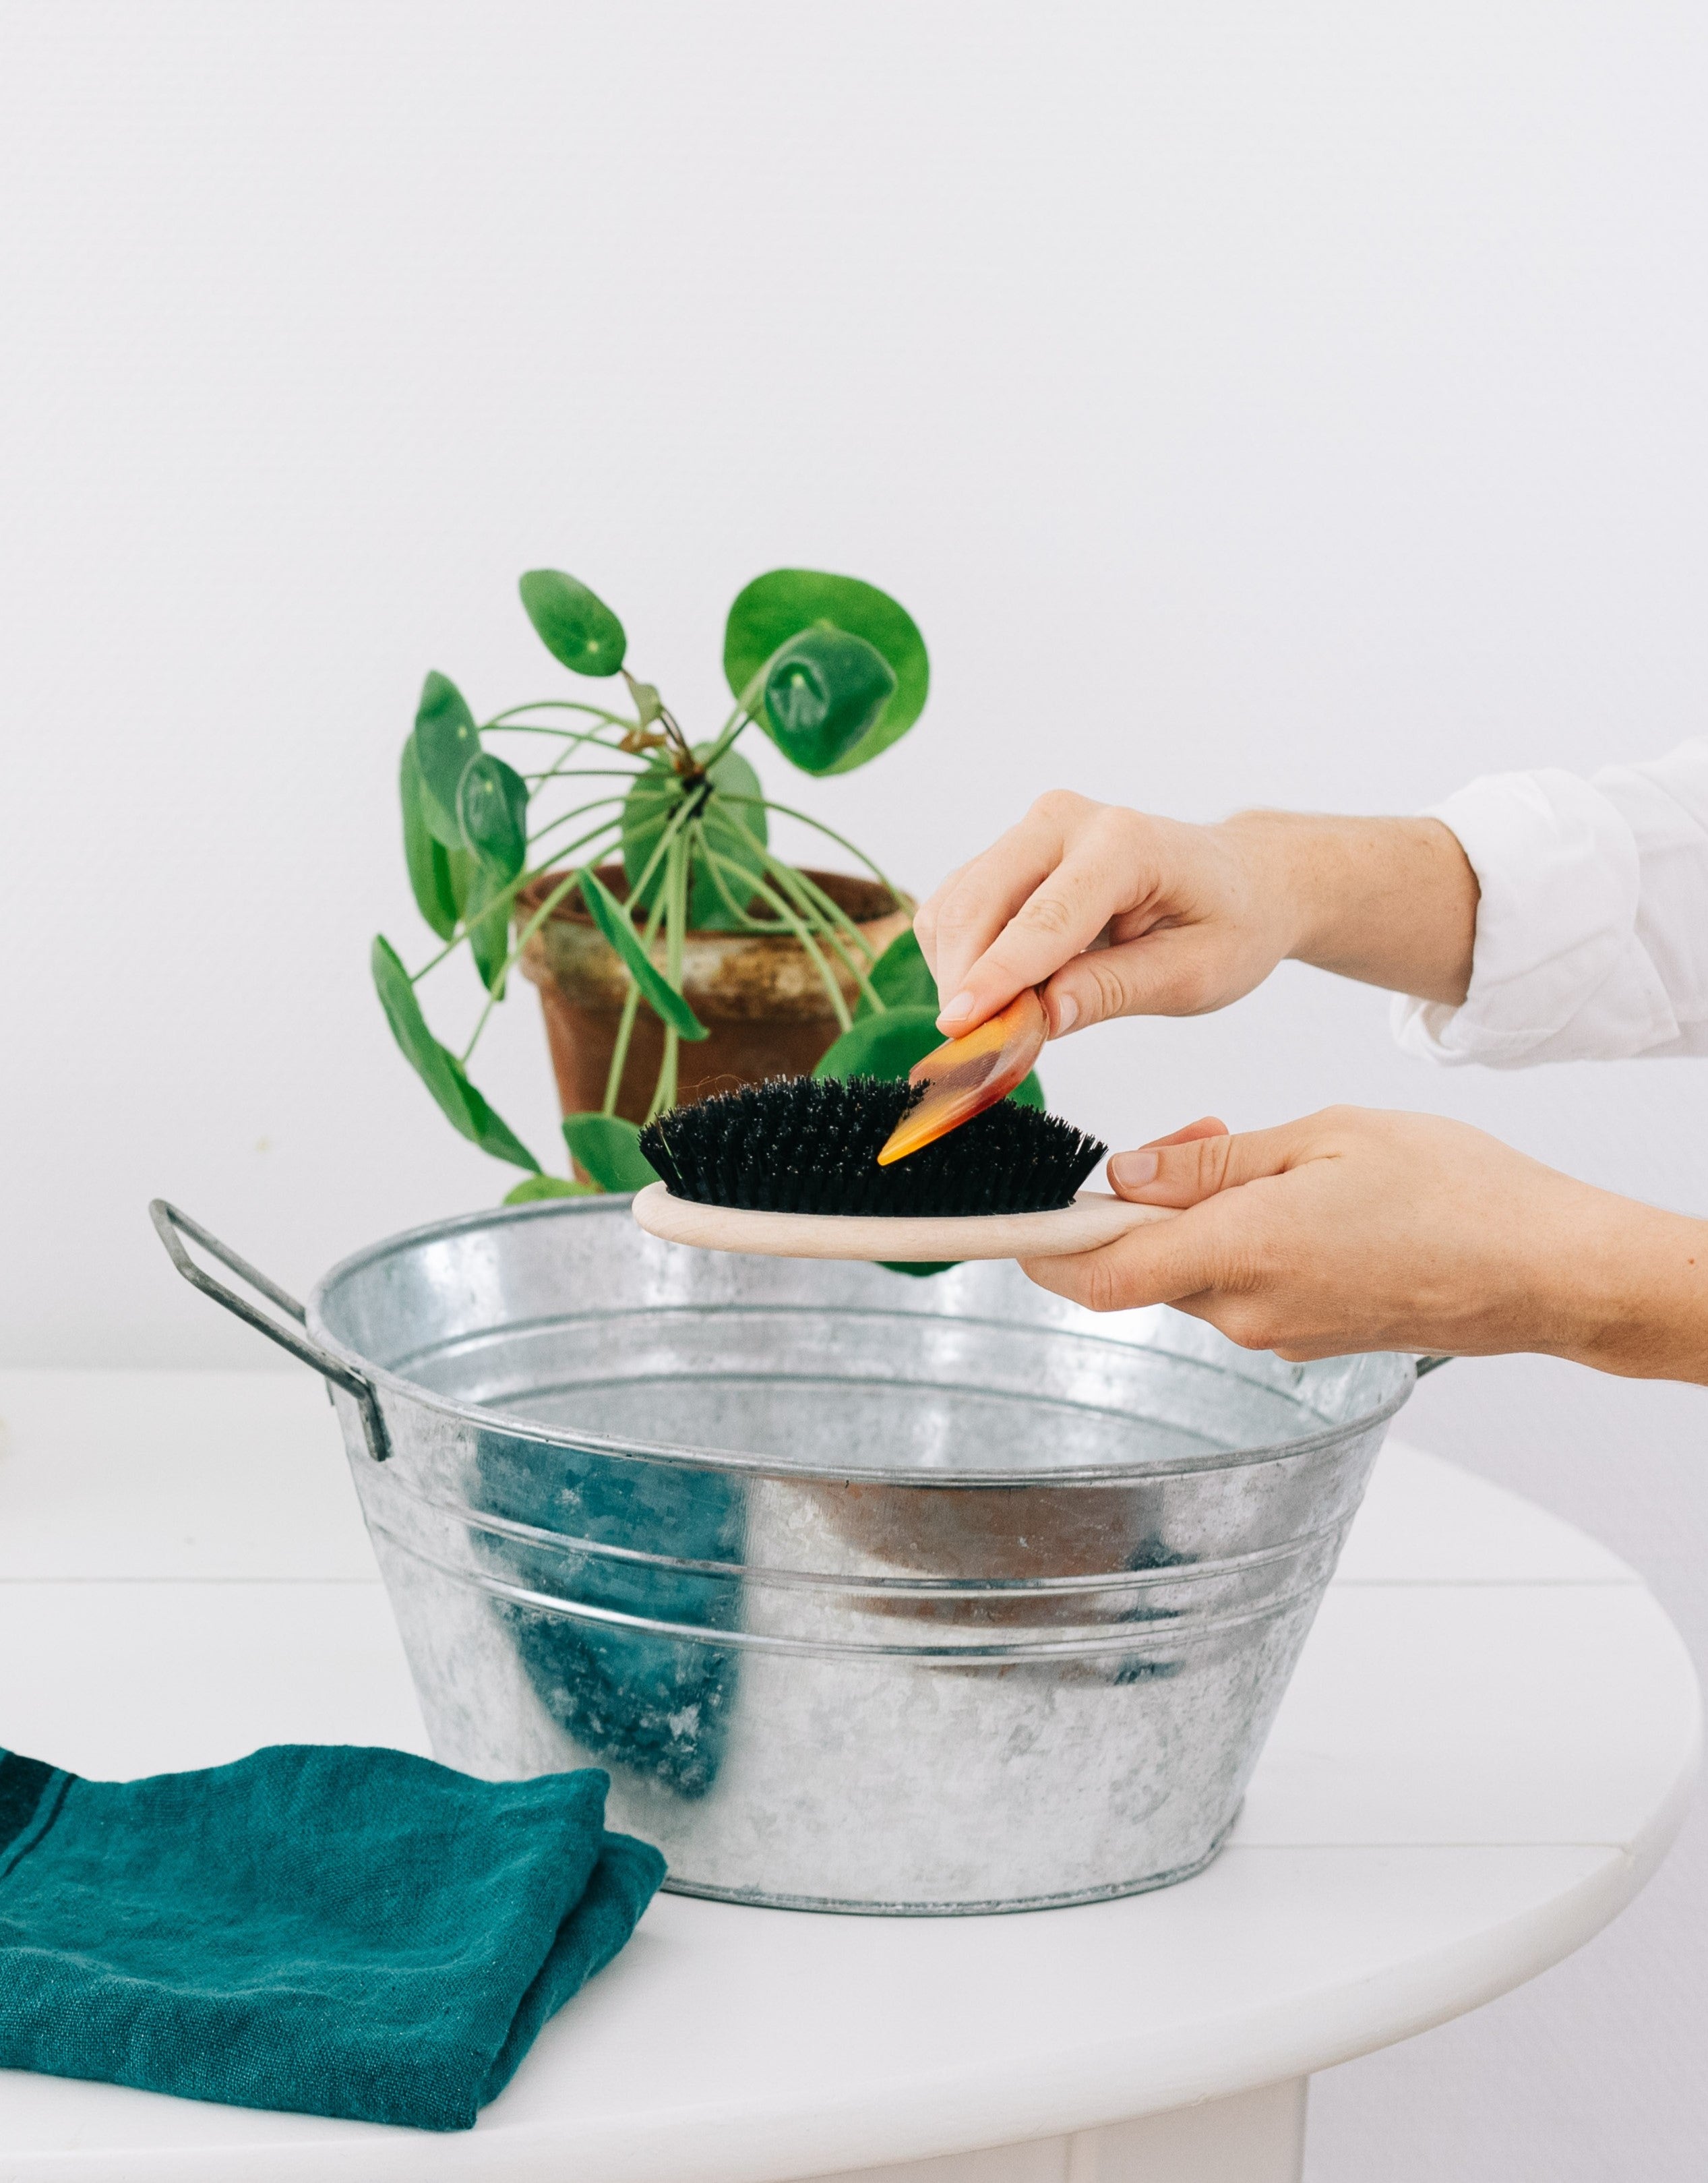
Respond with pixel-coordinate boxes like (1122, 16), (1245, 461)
(373, 568), (959, 1203)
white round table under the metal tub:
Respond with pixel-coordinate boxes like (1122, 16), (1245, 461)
(0, 1371), (1699, 2183)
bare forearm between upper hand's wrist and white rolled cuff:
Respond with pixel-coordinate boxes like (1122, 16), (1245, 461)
(1221, 812), (1477, 1009)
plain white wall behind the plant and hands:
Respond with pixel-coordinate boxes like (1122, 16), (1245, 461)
(0, 0), (1708, 2183)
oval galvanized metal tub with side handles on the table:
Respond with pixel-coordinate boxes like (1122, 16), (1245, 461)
(161, 1199), (1415, 1912)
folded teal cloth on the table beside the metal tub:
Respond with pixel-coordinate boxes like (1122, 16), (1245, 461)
(0, 1744), (665, 2130)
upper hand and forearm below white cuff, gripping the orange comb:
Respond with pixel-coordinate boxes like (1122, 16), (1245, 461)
(914, 790), (1477, 1037)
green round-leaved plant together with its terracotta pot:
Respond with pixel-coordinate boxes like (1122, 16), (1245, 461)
(373, 570), (968, 1203)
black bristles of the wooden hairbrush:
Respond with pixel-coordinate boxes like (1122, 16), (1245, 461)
(641, 1076), (1108, 1218)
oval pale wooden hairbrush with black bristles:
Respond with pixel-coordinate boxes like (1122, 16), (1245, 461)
(635, 1076), (1169, 1264)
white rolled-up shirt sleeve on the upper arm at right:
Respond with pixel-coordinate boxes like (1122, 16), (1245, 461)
(1394, 736), (1708, 1070)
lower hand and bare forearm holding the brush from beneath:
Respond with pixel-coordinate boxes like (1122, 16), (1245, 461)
(1025, 1107), (1708, 1382)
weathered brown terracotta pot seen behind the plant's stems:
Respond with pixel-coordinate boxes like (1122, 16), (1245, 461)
(515, 864), (912, 1122)
